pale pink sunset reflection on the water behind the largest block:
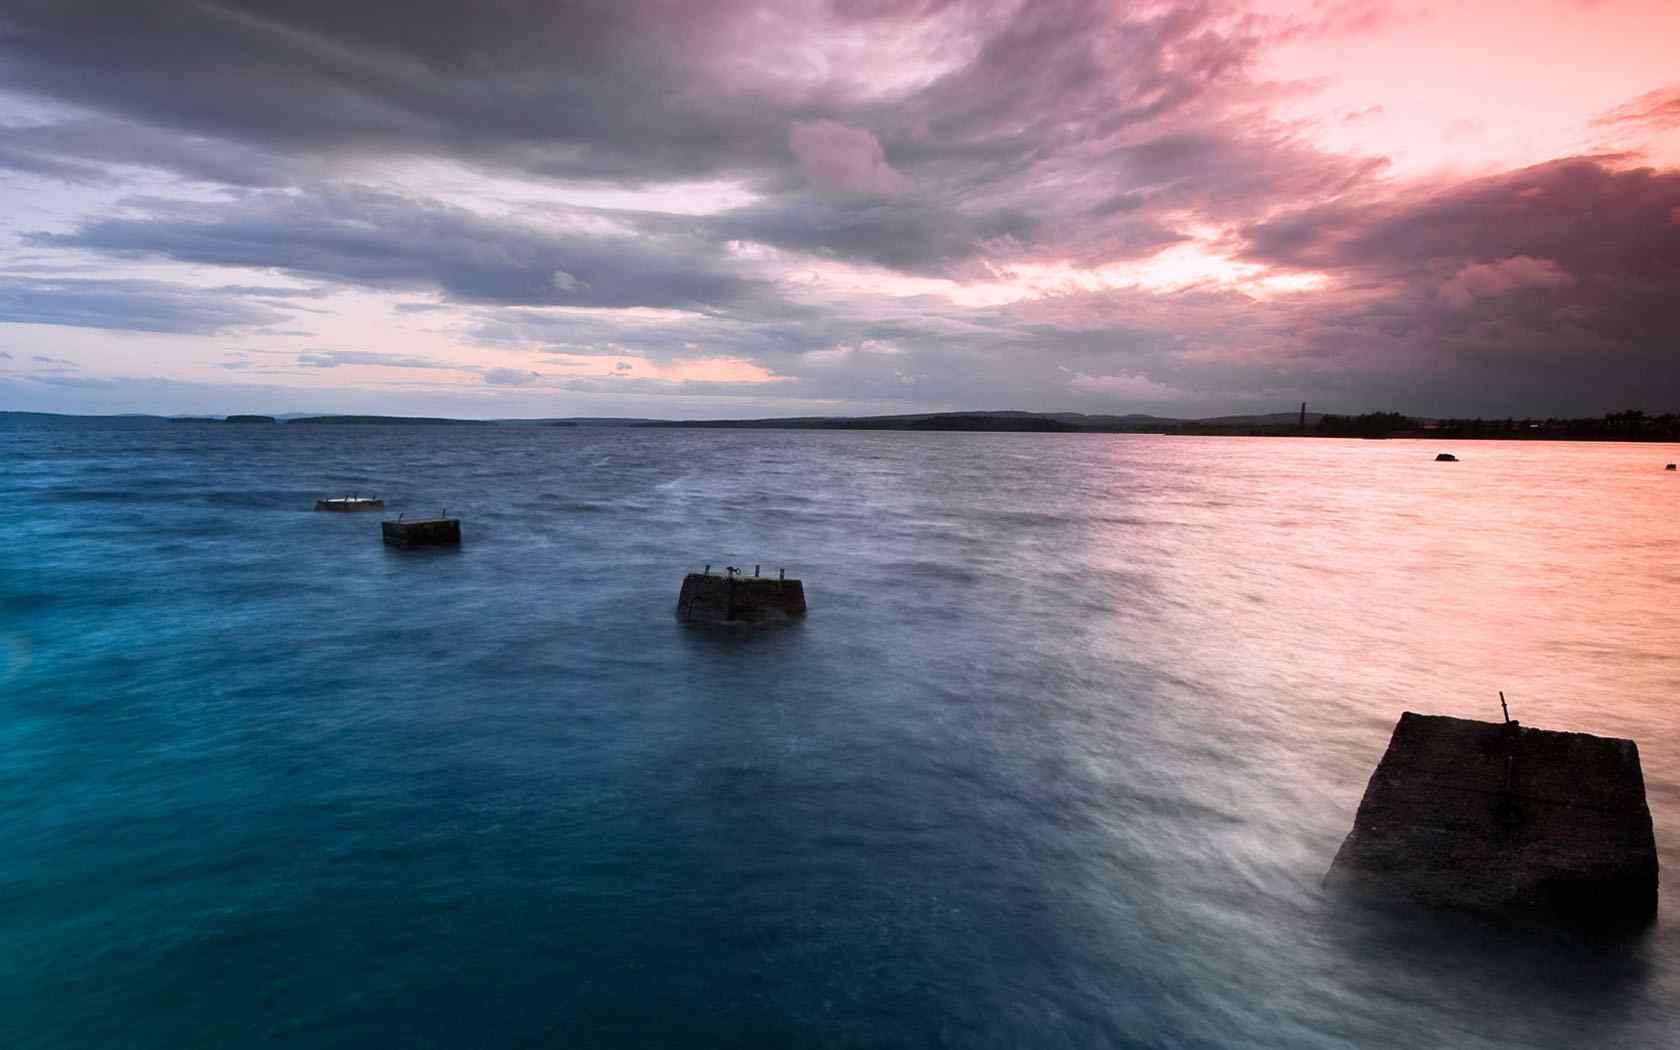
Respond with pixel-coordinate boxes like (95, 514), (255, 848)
(1089, 438), (1680, 922)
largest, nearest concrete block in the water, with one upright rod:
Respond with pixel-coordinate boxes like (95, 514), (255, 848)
(1324, 711), (1656, 927)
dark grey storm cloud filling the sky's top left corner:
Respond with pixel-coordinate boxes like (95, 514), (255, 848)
(0, 0), (782, 181)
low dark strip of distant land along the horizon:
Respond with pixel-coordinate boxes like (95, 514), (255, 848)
(0, 408), (1680, 442)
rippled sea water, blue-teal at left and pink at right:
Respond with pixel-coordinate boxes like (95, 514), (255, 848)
(0, 417), (1680, 1048)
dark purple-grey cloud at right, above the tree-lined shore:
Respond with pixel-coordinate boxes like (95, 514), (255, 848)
(1216, 158), (1680, 412)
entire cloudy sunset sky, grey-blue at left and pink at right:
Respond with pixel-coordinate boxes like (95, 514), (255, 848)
(0, 0), (1680, 418)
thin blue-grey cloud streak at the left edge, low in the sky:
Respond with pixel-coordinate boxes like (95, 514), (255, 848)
(0, 277), (286, 334)
